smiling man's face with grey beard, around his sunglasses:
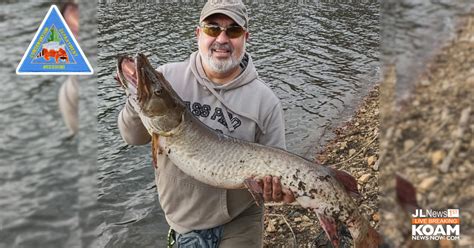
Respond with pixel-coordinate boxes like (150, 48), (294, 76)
(196, 14), (248, 73)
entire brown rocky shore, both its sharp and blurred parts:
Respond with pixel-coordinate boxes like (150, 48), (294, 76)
(264, 11), (474, 248)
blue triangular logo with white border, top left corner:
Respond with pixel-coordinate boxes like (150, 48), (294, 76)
(16, 5), (93, 75)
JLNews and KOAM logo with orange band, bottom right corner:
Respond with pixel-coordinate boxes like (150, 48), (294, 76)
(411, 209), (461, 240)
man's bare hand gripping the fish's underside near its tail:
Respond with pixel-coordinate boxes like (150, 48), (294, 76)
(258, 176), (295, 203)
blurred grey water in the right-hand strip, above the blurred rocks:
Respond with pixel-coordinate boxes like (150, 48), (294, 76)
(382, 0), (474, 102)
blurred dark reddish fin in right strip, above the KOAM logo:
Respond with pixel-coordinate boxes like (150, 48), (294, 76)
(395, 174), (420, 213)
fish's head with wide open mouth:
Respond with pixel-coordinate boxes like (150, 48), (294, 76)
(117, 54), (185, 135)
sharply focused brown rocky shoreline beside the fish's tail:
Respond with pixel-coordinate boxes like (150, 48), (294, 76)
(264, 84), (380, 247)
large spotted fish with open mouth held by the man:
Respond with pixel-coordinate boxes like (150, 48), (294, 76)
(116, 53), (380, 248)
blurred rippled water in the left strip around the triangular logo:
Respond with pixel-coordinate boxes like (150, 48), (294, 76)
(0, 1), (97, 248)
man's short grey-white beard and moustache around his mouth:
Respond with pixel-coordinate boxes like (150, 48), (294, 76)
(199, 42), (245, 73)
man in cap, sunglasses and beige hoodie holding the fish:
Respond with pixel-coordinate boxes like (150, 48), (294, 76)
(118, 0), (294, 247)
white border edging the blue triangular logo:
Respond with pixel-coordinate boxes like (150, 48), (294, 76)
(16, 5), (94, 75)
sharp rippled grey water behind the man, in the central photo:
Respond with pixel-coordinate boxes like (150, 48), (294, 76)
(97, 2), (380, 247)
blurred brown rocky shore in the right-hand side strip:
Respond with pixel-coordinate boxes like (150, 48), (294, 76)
(380, 12), (474, 248)
